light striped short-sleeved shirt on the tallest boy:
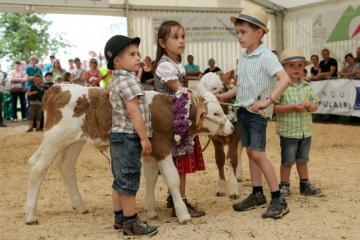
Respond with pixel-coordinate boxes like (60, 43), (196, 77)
(236, 43), (284, 118)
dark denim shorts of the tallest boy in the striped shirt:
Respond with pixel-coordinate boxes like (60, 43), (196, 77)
(237, 108), (268, 152)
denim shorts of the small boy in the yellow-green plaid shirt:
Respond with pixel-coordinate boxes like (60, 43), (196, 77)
(280, 136), (311, 166)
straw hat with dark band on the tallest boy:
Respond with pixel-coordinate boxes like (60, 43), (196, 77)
(230, 6), (269, 33)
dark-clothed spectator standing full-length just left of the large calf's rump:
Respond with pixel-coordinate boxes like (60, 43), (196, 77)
(26, 75), (44, 132)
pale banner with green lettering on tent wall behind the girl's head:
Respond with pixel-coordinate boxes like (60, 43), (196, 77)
(153, 14), (237, 43)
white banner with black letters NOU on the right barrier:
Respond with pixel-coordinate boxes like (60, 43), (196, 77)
(311, 79), (360, 117)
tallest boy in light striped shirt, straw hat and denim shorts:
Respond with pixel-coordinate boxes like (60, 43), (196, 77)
(218, 6), (290, 219)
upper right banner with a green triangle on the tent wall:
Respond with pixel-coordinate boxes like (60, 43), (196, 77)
(312, 4), (360, 44)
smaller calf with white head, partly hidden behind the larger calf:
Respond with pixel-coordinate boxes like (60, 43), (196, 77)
(197, 71), (243, 199)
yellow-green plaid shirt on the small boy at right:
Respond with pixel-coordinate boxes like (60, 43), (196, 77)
(276, 80), (319, 138)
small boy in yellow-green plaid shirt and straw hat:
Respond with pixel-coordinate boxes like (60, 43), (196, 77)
(274, 49), (321, 197)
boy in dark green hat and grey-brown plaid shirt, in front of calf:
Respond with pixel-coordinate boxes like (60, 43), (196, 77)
(105, 35), (158, 236)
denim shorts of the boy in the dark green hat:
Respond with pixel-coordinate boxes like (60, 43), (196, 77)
(109, 132), (141, 196)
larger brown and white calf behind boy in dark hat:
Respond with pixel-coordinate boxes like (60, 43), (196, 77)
(25, 84), (233, 224)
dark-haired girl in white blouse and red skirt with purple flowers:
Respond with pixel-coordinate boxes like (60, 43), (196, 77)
(155, 21), (205, 217)
